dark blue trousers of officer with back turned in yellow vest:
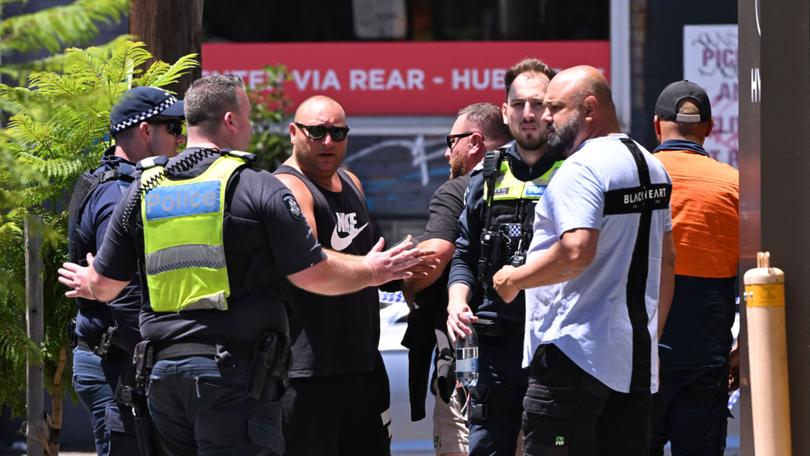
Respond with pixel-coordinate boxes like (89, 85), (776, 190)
(147, 356), (284, 456)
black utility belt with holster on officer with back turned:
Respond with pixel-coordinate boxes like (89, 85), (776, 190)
(133, 330), (290, 400)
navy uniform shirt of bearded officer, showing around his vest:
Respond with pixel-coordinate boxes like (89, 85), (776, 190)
(448, 142), (556, 322)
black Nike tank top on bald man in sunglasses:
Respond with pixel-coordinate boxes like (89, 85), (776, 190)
(276, 166), (380, 377)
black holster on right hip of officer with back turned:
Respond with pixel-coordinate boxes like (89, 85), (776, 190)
(248, 330), (290, 401)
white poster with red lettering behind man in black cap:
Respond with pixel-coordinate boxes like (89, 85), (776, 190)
(683, 24), (739, 168)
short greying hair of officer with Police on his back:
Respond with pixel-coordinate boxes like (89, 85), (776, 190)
(183, 74), (245, 127)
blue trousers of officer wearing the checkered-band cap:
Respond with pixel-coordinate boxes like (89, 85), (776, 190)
(73, 348), (139, 456)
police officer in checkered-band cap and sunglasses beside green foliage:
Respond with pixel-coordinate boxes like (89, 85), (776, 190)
(61, 87), (185, 455)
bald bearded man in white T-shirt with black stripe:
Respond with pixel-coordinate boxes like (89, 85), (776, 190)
(493, 66), (675, 455)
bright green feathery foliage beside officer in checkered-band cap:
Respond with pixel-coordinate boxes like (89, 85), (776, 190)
(0, 35), (197, 412)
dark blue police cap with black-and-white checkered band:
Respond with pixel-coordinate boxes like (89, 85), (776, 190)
(110, 87), (185, 135)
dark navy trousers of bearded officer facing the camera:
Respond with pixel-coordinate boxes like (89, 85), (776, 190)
(469, 334), (528, 456)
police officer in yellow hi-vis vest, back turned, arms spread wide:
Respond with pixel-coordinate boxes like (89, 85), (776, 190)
(62, 75), (426, 455)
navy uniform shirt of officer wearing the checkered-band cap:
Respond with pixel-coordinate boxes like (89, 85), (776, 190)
(71, 146), (141, 349)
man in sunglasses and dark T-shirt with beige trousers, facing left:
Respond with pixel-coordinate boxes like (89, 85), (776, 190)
(402, 103), (512, 456)
